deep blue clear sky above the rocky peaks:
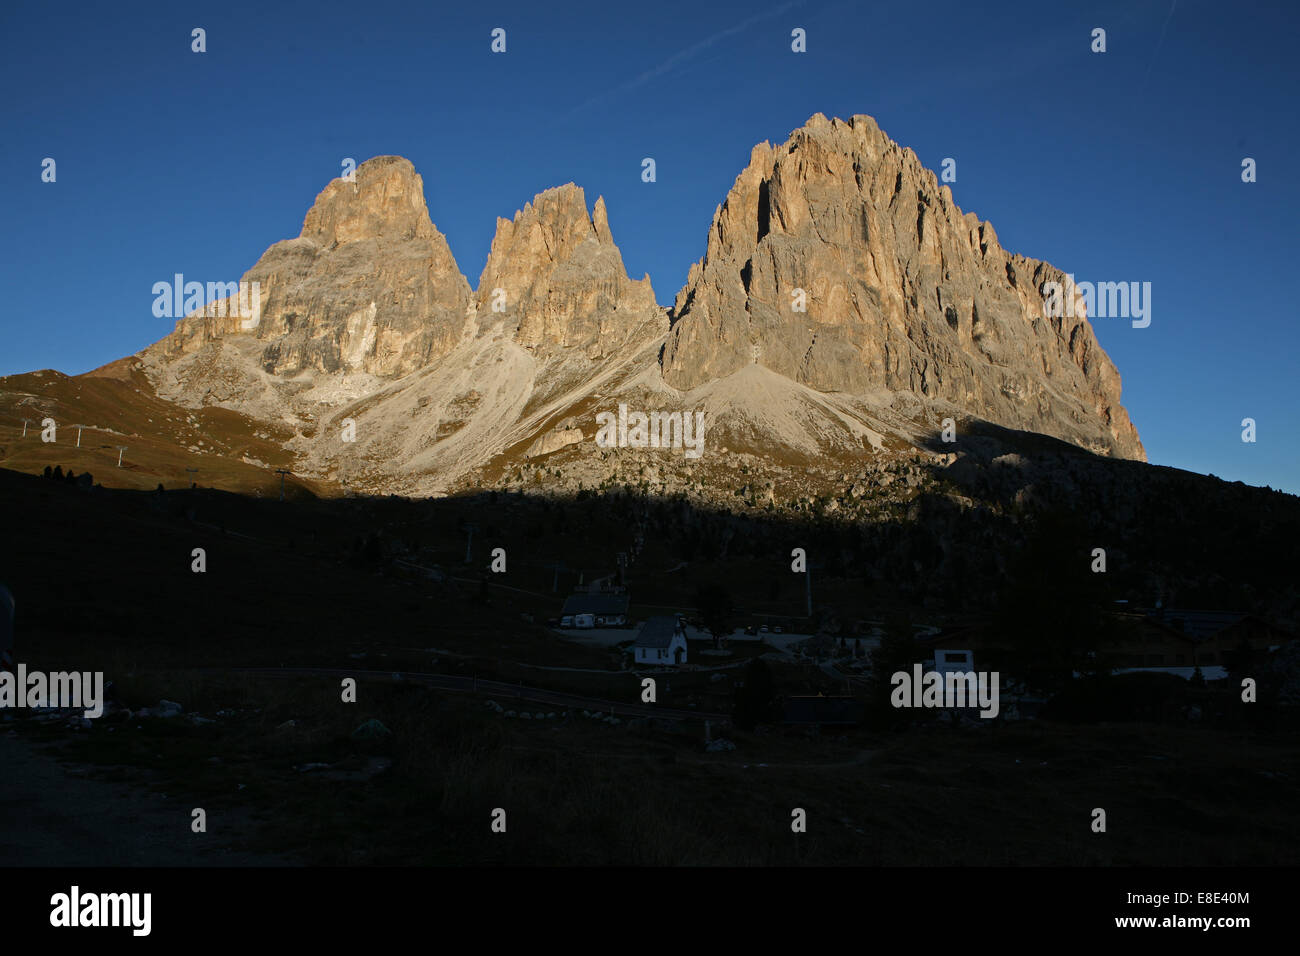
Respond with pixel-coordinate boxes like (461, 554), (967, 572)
(0, 0), (1300, 493)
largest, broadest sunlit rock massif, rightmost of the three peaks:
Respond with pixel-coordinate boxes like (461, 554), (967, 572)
(663, 114), (1145, 460)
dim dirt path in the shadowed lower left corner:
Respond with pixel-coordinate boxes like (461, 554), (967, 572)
(0, 731), (293, 866)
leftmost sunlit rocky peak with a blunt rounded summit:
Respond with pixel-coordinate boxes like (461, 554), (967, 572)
(142, 156), (469, 392)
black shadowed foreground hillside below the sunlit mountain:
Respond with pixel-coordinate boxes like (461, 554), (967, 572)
(0, 463), (1300, 865)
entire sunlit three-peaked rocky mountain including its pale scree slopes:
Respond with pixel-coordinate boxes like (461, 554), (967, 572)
(17, 113), (1145, 494)
